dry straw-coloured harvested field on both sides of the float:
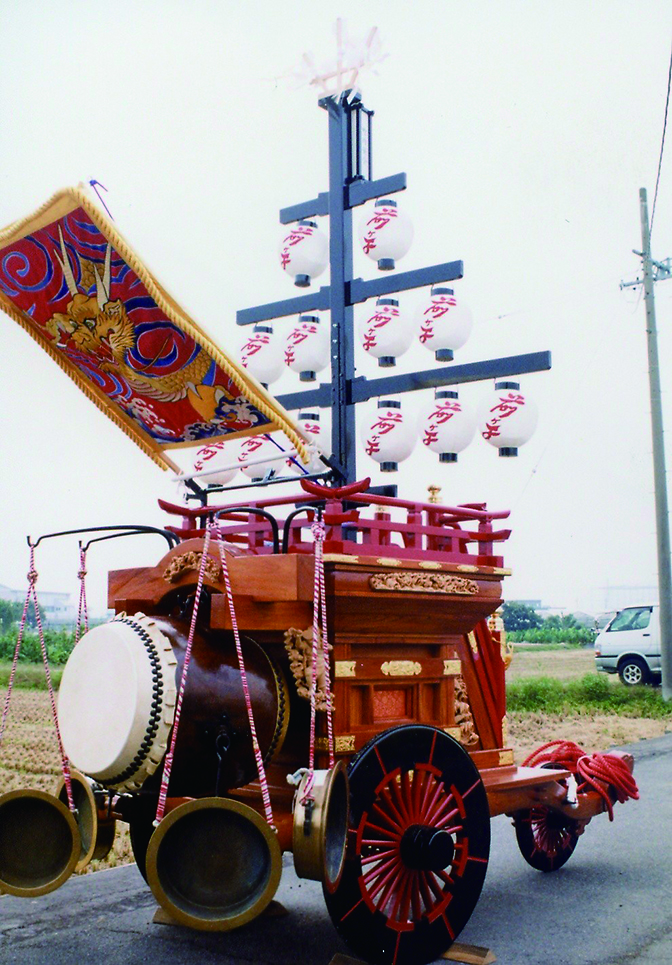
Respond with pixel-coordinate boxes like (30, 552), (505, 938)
(0, 649), (672, 873)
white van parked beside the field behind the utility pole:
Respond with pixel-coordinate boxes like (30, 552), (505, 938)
(595, 604), (661, 687)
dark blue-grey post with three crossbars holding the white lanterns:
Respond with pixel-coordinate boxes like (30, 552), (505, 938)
(236, 90), (551, 483)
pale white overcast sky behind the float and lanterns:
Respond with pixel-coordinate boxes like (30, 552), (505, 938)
(0, 0), (672, 610)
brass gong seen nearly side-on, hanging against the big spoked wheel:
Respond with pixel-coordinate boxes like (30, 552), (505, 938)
(293, 761), (349, 891)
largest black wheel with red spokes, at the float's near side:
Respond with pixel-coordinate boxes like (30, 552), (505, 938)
(323, 725), (490, 965)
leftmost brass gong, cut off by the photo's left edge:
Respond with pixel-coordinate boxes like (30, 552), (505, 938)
(0, 790), (81, 898)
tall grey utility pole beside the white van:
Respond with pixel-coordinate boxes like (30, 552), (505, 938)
(621, 188), (672, 700)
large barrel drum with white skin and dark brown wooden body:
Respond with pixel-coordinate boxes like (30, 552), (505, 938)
(59, 613), (289, 797)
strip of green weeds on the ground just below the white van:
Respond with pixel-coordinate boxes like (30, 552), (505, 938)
(506, 674), (672, 718)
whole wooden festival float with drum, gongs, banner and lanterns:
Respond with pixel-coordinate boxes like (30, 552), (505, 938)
(0, 28), (637, 965)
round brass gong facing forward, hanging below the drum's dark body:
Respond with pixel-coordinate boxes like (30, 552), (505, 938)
(146, 797), (282, 931)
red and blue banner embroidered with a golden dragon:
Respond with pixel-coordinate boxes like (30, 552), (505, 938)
(0, 188), (305, 469)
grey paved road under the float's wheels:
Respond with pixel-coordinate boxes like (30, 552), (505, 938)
(0, 735), (672, 965)
